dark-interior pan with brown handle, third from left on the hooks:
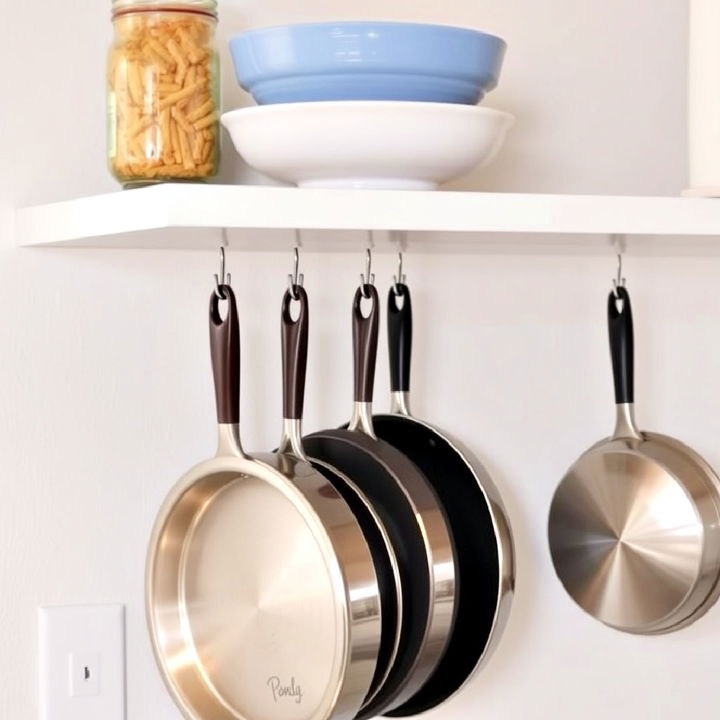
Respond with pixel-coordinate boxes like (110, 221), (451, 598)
(304, 284), (456, 720)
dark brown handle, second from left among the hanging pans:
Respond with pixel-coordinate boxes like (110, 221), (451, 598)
(281, 285), (309, 420)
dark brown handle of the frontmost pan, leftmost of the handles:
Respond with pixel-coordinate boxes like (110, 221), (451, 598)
(210, 285), (240, 425)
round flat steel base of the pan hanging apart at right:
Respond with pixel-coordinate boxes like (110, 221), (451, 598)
(549, 446), (704, 632)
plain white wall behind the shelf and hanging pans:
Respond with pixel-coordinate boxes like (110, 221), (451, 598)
(0, 0), (720, 720)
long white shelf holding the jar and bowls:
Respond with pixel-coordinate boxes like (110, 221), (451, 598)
(16, 184), (720, 251)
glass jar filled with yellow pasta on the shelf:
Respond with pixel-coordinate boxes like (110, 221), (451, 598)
(108, 0), (220, 186)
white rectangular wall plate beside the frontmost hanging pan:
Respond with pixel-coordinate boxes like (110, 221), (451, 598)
(38, 605), (125, 720)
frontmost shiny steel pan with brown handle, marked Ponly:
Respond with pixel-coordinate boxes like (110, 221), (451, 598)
(146, 285), (381, 720)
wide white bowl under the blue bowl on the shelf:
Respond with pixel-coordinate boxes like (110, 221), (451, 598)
(222, 101), (514, 190)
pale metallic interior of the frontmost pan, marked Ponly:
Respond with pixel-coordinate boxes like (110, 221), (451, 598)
(153, 473), (347, 720)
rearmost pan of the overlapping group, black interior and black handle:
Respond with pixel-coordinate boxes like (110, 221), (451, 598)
(373, 283), (515, 717)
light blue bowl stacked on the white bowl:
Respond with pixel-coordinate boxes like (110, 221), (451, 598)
(230, 22), (506, 105)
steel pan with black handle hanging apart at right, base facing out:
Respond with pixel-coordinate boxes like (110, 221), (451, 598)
(548, 287), (720, 634)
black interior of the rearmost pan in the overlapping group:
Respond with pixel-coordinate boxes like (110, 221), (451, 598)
(373, 415), (500, 717)
